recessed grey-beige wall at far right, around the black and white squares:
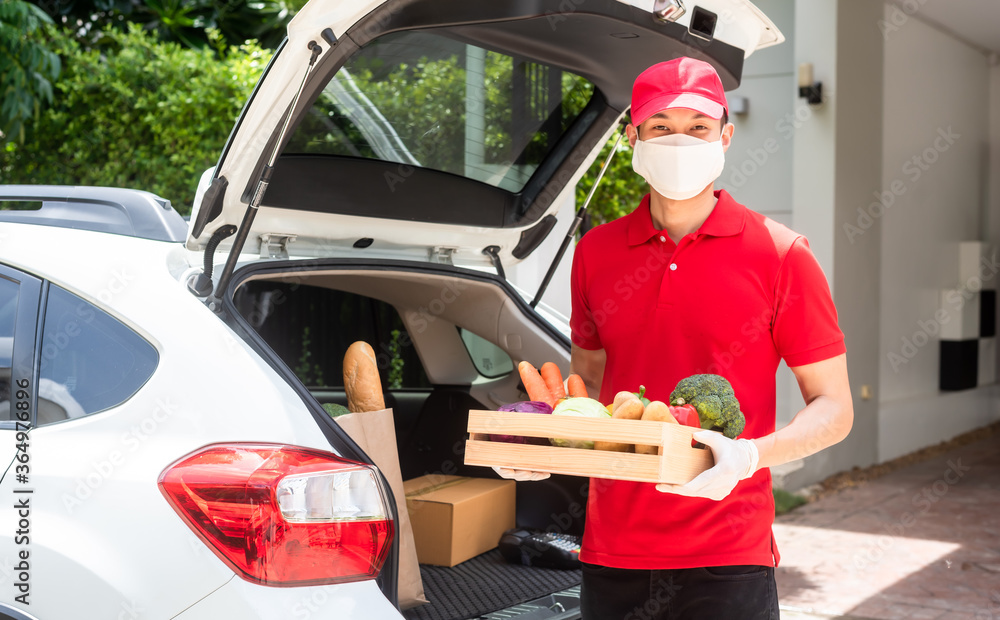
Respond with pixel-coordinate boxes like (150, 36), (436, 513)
(876, 3), (1000, 461)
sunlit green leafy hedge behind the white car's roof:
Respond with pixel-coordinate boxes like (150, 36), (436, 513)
(0, 26), (272, 213)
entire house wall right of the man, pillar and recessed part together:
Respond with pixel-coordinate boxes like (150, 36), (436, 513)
(770, 0), (1000, 488)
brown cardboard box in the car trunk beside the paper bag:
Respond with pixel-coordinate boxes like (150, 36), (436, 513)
(403, 474), (514, 566)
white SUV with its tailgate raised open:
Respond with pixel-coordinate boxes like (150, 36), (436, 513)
(0, 0), (782, 620)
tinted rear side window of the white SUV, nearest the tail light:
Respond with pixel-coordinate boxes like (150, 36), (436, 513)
(37, 285), (159, 426)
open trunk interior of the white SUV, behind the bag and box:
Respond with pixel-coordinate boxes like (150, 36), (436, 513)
(234, 261), (588, 620)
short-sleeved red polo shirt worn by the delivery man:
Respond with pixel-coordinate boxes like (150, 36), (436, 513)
(570, 191), (845, 569)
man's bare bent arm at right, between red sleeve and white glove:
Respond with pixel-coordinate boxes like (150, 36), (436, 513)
(753, 355), (854, 469)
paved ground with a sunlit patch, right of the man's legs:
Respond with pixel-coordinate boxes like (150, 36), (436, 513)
(774, 432), (1000, 620)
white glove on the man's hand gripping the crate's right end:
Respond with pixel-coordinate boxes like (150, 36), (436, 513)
(656, 431), (760, 501)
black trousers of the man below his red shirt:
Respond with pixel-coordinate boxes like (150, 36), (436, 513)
(580, 563), (778, 620)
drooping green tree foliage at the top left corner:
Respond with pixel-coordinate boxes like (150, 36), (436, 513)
(0, 0), (60, 144)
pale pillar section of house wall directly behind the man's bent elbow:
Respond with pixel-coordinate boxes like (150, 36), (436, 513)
(784, 0), (883, 488)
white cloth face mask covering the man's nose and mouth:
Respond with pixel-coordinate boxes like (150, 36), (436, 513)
(632, 133), (726, 200)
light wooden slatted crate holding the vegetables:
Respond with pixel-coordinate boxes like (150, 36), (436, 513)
(465, 410), (715, 484)
